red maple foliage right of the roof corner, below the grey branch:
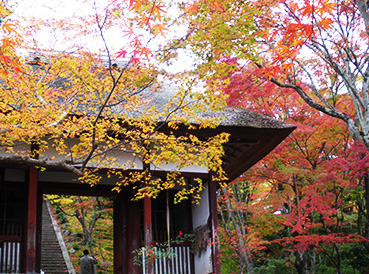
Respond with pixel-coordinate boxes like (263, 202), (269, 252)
(219, 63), (366, 273)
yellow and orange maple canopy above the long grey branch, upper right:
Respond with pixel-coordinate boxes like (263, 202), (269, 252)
(162, 0), (369, 148)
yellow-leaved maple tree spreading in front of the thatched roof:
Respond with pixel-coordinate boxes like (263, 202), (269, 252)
(0, 2), (228, 200)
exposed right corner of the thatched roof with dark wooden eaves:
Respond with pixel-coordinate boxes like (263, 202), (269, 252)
(139, 84), (296, 181)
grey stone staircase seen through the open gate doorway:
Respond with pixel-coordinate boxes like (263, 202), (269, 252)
(41, 201), (74, 274)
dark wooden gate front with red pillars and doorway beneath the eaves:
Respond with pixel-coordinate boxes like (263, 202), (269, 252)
(0, 168), (201, 274)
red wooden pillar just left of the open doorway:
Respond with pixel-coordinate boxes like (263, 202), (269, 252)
(24, 167), (40, 273)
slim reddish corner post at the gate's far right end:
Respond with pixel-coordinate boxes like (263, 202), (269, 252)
(209, 179), (220, 274)
